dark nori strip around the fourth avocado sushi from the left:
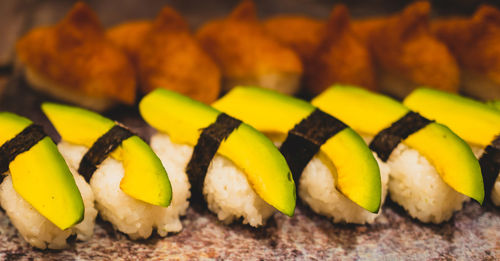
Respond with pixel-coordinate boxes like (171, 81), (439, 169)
(280, 109), (347, 184)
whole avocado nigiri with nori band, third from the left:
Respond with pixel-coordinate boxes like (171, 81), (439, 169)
(139, 89), (295, 227)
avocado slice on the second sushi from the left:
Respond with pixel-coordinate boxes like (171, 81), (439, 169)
(42, 103), (172, 207)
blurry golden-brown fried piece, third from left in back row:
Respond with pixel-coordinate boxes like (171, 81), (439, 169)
(196, 1), (302, 94)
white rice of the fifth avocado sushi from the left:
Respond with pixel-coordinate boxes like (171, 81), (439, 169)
(387, 143), (469, 224)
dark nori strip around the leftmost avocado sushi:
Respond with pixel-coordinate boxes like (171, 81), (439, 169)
(0, 124), (47, 174)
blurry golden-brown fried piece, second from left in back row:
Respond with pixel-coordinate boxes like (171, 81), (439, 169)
(108, 7), (220, 103)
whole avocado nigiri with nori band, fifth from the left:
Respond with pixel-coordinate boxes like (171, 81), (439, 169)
(311, 85), (484, 223)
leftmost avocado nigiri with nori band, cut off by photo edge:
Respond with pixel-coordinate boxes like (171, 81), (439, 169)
(0, 112), (97, 249)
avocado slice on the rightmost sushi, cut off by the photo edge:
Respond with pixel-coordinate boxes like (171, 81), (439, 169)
(403, 88), (500, 146)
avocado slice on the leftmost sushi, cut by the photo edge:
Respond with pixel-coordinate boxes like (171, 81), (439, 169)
(0, 112), (84, 230)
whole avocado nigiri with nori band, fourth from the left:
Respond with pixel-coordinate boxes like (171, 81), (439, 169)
(212, 87), (388, 224)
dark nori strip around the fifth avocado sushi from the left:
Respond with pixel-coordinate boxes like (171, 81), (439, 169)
(370, 111), (433, 162)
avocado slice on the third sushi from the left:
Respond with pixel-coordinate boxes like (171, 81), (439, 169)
(139, 89), (295, 216)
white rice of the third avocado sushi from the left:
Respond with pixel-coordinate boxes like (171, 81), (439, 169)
(151, 133), (275, 227)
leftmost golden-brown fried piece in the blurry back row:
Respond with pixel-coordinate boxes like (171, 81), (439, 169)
(16, 2), (136, 110)
